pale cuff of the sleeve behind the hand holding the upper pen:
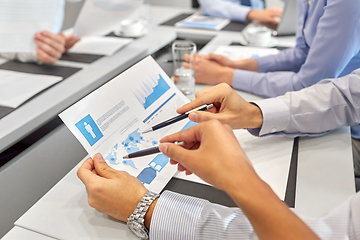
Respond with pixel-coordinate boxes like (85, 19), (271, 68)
(249, 98), (290, 136)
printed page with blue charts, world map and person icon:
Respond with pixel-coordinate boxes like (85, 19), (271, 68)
(59, 57), (195, 192)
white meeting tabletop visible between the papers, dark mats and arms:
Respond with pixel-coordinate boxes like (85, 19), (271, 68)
(0, 4), (355, 239)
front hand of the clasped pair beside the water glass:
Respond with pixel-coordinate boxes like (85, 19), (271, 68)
(183, 55), (235, 85)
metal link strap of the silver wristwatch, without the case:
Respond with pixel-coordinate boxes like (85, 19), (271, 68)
(127, 191), (160, 237)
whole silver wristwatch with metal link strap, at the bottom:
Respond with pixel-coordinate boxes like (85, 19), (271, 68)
(127, 191), (160, 240)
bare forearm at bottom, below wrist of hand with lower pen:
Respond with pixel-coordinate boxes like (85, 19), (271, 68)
(227, 176), (319, 240)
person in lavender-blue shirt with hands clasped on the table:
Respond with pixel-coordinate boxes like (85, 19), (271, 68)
(184, 0), (360, 174)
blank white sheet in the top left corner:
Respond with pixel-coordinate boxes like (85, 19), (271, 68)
(0, 0), (58, 52)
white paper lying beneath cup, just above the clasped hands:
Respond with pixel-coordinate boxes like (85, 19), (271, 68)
(214, 45), (279, 61)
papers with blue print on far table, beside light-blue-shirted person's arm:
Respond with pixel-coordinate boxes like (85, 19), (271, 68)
(175, 13), (230, 30)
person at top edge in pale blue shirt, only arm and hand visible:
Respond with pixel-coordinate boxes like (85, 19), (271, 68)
(199, 0), (283, 25)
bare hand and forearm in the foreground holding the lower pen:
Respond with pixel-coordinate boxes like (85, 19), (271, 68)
(160, 120), (319, 240)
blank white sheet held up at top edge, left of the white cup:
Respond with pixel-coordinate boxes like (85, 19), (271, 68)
(74, 0), (142, 37)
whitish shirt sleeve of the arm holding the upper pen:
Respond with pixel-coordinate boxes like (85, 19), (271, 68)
(249, 69), (360, 137)
